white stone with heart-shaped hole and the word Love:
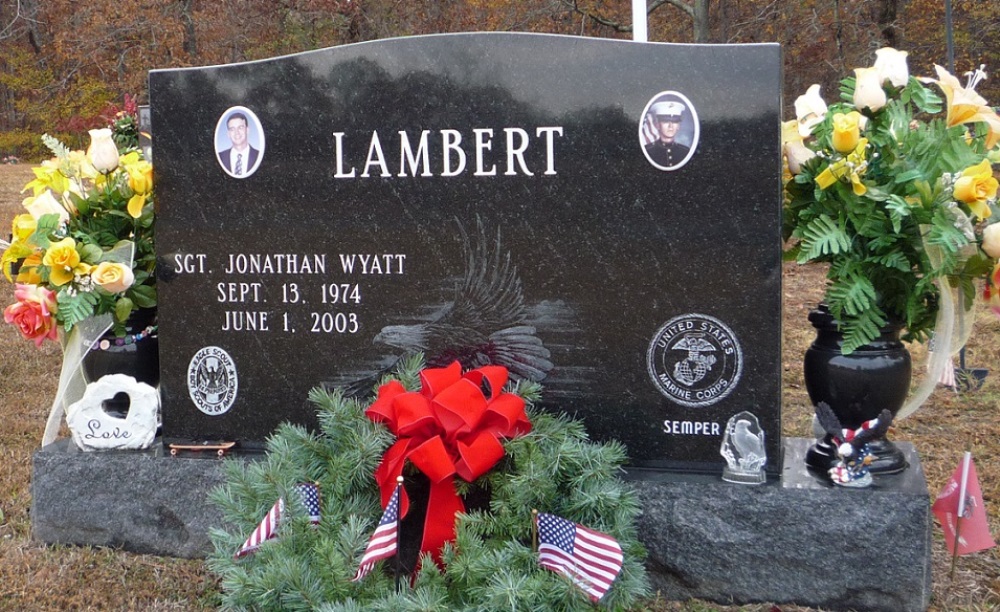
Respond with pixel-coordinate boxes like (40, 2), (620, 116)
(66, 374), (160, 451)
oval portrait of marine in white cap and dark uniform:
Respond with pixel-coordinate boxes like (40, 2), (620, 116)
(639, 91), (700, 170)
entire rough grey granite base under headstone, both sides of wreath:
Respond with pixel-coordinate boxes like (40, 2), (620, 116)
(31, 438), (932, 610)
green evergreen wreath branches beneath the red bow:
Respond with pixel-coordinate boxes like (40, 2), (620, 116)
(208, 355), (649, 611)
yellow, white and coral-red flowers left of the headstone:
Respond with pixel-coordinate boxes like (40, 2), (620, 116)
(0, 113), (156, 346)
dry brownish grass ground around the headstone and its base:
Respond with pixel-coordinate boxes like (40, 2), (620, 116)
(0, 165), (1000, 612)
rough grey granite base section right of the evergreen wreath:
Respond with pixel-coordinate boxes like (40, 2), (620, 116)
(629, 438), (933, 611)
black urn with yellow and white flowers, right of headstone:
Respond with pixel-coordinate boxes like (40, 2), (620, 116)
(783, 49), (1000, 472)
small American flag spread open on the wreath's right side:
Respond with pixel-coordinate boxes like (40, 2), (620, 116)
(538, 513), (624, 602)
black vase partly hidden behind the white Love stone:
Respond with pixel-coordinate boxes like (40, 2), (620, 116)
(83, 308), (160, 416)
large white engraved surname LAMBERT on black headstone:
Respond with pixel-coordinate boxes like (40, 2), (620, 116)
(333, 126), (563, 178)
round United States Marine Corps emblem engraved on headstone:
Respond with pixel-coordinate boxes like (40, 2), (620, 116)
(646, 314), (743, 408)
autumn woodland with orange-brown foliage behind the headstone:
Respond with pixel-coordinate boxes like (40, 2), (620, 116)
(0, 0), (1000, 161)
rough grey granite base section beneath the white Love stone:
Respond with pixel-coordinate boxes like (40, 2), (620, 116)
(31, 439), (254, 558)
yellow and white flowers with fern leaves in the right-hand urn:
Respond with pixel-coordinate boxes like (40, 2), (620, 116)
(782, 48), (1000, 354)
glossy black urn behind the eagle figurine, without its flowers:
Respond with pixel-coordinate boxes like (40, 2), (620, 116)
(804, 305), (912, 474)
